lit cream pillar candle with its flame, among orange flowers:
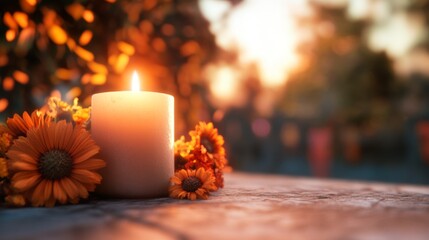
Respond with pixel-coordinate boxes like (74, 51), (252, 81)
(91, 72), (174, 198)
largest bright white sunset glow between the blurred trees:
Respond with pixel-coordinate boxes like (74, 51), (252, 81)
(201, 0), (305, 87)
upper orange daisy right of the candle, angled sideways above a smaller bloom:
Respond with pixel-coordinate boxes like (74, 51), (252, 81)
(189, 122), (227, 168)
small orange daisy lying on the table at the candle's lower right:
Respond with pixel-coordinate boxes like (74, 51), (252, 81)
(169, 168), (216, 200)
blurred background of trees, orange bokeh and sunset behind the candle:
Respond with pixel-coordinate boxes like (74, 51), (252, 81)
(0, 0), (429, 184)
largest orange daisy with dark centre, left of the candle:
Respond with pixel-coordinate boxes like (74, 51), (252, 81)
(7, 121), (105, 206)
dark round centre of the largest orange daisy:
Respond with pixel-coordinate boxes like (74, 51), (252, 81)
(39, 149), (73, 180)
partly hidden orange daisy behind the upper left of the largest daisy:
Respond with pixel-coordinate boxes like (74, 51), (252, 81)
(6, 110), (52, 137)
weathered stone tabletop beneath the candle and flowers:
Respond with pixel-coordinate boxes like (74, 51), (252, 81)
(0, 173), (429, 240)
